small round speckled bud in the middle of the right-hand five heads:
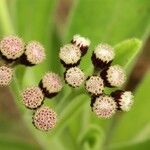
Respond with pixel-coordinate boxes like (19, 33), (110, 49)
(85, 76), (104, 96)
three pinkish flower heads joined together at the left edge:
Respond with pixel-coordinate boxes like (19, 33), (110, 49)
(0, 35), (45, 86)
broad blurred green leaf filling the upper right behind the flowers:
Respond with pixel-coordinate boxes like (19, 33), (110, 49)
(64, 0), (150, 73)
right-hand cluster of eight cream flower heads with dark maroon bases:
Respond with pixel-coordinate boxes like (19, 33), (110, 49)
(59, 35), (133, 118)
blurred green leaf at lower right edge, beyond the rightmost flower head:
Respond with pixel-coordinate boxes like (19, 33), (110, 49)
(109, 72), (150, 144)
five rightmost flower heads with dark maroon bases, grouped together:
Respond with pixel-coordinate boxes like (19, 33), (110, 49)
(89, 43), (133, 118)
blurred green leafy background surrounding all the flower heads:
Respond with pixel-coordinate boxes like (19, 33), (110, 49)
(0, 0), (150, 150)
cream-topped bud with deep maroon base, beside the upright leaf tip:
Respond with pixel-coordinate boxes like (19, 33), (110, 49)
(92, 44), (115, 69)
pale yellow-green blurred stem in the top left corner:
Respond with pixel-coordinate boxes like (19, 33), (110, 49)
(0, 0), (14, 34)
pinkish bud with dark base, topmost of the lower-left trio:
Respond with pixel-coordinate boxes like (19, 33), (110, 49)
(39, 72), (63, 98)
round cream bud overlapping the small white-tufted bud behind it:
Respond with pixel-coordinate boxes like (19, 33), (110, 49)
(59, 44), (81, 67)
